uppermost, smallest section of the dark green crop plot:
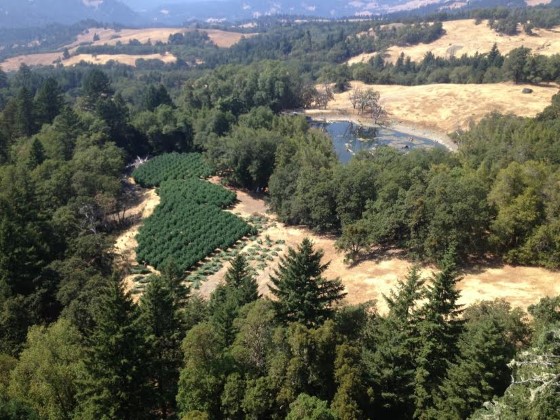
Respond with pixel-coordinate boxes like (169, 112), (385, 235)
(132, 153), (212, 187)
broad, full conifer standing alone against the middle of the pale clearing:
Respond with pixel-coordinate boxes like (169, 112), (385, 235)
(269, 238), (346, 327)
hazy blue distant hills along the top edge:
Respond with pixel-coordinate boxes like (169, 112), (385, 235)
(0, 0), (550, 28)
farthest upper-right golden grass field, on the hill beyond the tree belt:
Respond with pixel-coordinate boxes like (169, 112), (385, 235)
(348, 19), (560, 64)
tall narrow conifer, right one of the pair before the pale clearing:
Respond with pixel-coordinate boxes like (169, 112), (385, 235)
(414, 252), (462, 418)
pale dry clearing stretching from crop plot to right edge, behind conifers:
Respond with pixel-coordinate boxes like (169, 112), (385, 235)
(199, 185), (560, 311)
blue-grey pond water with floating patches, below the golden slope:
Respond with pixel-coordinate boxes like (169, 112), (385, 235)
(311, 121), (445, 163)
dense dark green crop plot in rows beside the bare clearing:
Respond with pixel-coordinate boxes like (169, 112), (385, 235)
(132, 153), (257, 291)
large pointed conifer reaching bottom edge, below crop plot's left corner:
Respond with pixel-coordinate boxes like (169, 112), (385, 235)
(78, 279), (151, 420)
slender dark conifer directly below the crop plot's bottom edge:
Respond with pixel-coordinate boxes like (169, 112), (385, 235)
(140, 276), (185, 418)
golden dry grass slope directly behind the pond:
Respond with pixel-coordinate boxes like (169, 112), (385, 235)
(311, 82), (558, 137)
